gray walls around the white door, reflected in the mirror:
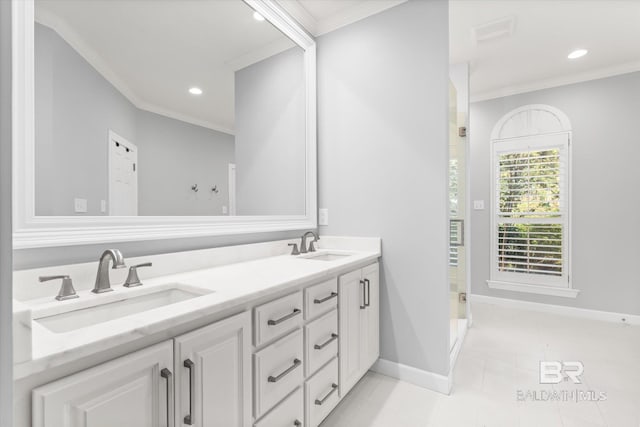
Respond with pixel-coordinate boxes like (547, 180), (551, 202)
(35, 24), (234, 215)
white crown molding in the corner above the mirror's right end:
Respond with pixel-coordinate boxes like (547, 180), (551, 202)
(276, 0), (407, 37)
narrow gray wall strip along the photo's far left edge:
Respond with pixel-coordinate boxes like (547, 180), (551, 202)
(0, 1), (13, 427)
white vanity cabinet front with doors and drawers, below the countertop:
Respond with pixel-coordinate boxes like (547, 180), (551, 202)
(32, 263), (379, 427)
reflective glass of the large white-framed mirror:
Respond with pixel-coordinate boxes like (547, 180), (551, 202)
(34, 0), (306, 216)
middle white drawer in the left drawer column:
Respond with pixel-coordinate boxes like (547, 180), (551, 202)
(253, 329), (304, 418)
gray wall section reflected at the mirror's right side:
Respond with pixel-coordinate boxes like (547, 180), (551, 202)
(235, 47), (306, 215)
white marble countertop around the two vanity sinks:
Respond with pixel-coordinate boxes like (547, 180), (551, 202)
(14, 238), (381, 379)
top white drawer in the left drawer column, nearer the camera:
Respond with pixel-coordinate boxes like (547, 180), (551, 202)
(253, 292), (303, 346)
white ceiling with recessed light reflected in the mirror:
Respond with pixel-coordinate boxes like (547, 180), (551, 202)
(36, 0), (294, 133)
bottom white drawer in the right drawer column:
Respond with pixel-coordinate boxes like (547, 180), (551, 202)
(304, 358), (340, 427)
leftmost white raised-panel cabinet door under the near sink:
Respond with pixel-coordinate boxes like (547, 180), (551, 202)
(32, 341), (173, 427)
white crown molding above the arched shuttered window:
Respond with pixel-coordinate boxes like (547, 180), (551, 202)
(470, 61), (640, 102)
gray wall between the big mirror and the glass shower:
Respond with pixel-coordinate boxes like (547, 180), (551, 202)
(318, 0), (449, 375)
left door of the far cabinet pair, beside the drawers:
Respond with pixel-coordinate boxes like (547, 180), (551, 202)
(338, 270), (365, 396)
